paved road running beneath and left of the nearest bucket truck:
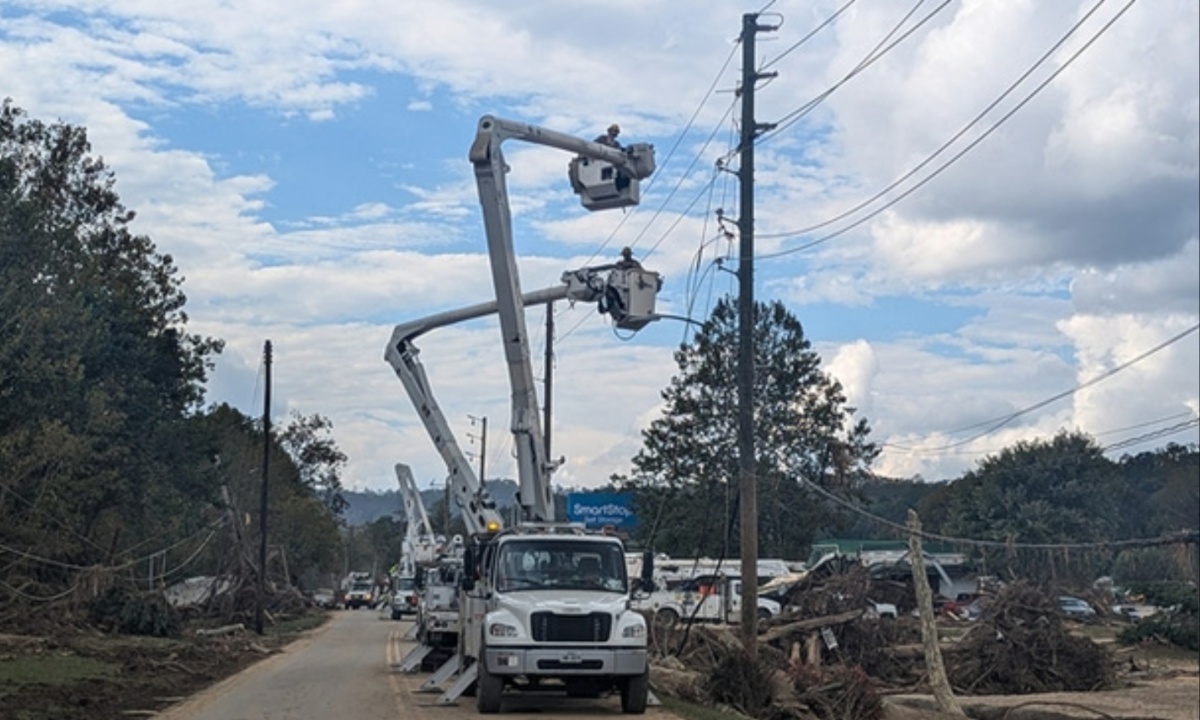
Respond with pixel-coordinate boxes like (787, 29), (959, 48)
(156, 610), (678, 720)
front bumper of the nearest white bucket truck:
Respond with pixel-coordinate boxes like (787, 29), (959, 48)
(484, 647), (647, 676)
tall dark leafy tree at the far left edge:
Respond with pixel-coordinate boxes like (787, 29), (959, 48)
(0, 100), (222, 581)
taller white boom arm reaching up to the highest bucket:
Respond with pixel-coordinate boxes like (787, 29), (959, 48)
(470, 115), (656, 522)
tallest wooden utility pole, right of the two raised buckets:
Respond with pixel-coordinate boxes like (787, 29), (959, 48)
(738, 13), (776, 653)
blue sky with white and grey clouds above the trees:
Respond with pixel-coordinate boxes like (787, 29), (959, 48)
(0, 0), (1200, 490)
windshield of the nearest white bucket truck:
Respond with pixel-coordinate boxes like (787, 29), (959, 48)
(496, 540), (628, 593)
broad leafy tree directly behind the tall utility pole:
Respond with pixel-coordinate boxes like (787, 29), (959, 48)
(617, 299), (878, 557)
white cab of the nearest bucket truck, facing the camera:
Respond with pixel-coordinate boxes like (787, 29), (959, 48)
(466, 526), (649, 713)
